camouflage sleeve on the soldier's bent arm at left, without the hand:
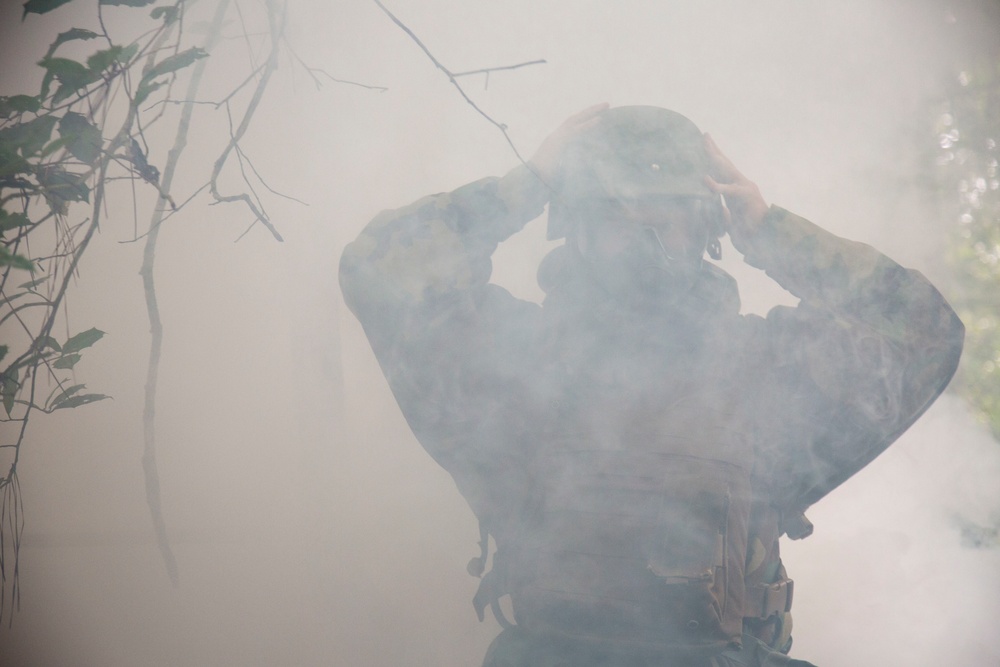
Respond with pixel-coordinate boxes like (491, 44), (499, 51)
(340, 166), (548, 469)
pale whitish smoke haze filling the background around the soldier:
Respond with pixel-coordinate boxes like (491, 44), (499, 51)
(0, 0), (1000, 667)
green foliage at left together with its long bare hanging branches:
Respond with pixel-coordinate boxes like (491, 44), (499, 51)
(0, 0), (292, 616)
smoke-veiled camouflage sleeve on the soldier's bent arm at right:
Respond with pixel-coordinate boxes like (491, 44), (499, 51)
(745, 207), (964, 520)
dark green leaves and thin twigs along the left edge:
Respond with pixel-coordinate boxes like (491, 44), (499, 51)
(0, 0), (215, 568)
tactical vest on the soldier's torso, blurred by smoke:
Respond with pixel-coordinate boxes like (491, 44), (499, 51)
(470, 264), (791, 655)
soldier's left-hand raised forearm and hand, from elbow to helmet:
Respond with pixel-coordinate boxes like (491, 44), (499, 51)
(340, 104), (607, 344)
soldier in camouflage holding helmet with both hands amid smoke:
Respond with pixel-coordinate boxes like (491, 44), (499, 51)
(340, 105), (964, 667)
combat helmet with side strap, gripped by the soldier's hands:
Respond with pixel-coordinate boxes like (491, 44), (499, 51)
(548, 106), (723, 259)
